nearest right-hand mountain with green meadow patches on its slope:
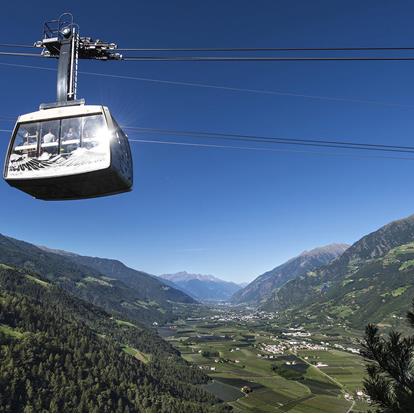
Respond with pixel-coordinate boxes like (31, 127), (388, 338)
(263, 215), (414, 328)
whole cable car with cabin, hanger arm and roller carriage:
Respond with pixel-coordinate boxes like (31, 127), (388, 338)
(4, 13), (133, 200)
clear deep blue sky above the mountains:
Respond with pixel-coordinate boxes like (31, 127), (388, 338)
(0, 0), (414, 282)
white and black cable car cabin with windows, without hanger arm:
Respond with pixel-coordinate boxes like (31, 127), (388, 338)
(4, 105), (133, 200)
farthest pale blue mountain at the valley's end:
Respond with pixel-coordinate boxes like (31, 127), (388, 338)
(160, 272), (240, 301)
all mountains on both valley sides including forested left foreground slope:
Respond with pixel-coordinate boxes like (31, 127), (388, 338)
(0, 215), (414, 412)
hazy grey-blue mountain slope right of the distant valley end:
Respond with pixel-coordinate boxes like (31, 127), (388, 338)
(232, 244), (349, 304)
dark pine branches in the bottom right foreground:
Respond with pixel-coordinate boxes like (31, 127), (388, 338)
(362, 301), (414, 413)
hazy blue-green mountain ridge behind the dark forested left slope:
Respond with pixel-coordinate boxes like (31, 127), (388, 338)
(0, 235), (194, 323)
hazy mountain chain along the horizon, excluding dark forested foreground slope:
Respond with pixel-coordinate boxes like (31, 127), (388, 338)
(4, 209), (414, 328)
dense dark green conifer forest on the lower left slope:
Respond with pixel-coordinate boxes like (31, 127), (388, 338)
(0, 265), (227, 412)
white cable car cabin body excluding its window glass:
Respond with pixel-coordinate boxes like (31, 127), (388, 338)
(4, 105), (133, 200)
